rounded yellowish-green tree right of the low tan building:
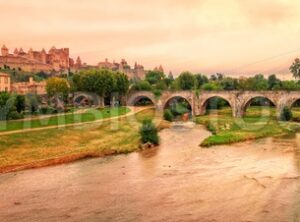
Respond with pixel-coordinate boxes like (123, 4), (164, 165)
(46, 77), (70, 99)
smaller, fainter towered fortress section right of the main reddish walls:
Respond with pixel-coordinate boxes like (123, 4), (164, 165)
(98, 59), (146, 79)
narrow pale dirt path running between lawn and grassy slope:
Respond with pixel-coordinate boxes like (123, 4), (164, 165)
(0, 106), (150, 136)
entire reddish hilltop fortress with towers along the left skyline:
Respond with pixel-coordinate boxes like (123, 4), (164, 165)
(0, 45), (164, 79)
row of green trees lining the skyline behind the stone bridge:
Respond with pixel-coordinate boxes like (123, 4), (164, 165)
(133, 72), (300, 91)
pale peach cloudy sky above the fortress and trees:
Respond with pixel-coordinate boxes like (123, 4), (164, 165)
(0, 0), (300, 78)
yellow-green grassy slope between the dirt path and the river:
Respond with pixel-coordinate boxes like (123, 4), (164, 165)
(0, 109), (168, 173)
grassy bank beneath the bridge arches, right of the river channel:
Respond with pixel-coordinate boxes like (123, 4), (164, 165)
(196, 107), (300, 147)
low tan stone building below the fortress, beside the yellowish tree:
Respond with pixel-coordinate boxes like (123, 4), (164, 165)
(11, 77), (46, 95)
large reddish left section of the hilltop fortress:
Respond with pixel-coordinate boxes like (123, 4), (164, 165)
(0, 45), (82, 72)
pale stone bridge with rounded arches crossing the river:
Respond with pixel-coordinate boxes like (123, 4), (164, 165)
(127, 91), (300, 117)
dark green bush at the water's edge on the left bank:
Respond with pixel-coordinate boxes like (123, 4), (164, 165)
(140, 119), (159, 145)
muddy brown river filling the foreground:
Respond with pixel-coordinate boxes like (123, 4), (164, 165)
(0, 126), (300, 222)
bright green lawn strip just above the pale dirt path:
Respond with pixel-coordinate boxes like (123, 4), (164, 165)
(0, 107), (130, 132)
